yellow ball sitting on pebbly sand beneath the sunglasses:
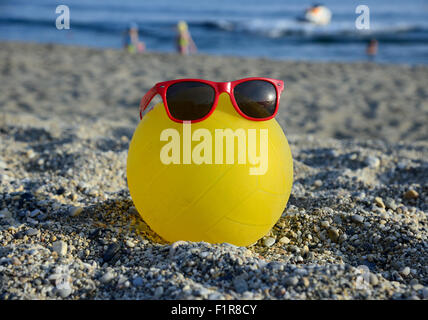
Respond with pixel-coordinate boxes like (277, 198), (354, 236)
(127, 93), (293, 246)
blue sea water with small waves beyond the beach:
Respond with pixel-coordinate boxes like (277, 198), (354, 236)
(0, 0), (428, 64)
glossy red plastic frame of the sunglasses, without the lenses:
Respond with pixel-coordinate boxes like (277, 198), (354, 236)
(140, 77), (284, 123)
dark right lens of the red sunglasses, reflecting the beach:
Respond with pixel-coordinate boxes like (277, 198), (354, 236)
(233, 80), (277, 119)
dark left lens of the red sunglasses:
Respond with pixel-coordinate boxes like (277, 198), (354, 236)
(166, 81), (215, 121)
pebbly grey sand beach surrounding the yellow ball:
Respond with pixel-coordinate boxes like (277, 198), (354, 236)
(0, 42), (428, 300)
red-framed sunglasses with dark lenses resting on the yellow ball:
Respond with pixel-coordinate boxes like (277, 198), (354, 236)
(140, 77), (284, 123)
